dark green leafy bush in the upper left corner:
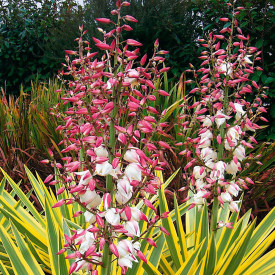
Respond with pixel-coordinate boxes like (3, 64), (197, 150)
(0, 0), (82, 95)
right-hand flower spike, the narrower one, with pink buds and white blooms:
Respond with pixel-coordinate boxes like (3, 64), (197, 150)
(177, 4), (267, 222)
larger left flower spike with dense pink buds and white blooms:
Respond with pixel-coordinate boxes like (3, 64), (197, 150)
(46, 1), (169, 274)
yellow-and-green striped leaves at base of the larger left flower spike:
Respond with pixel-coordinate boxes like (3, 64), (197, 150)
(0, 167), (181, 275)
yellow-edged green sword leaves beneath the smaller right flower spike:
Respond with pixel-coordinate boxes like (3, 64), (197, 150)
(134, 171), (275, 275)
